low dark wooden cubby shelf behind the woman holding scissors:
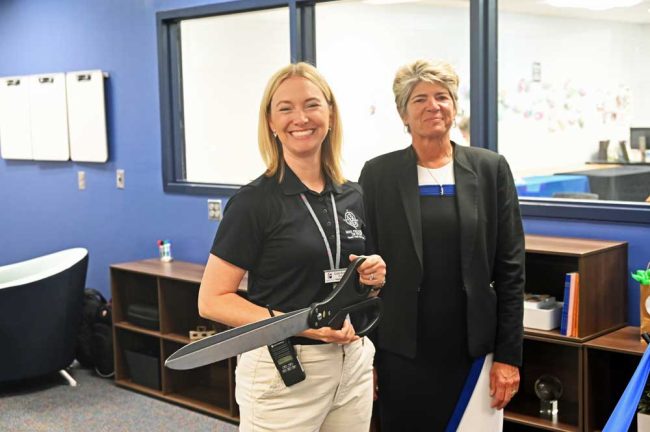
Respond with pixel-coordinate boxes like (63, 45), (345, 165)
(111, 259), (245, 422)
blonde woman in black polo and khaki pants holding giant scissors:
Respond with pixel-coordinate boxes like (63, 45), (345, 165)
(199, 63), (386, 432)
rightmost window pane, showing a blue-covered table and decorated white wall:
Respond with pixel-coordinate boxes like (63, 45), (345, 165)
(498, 0), (650, 202)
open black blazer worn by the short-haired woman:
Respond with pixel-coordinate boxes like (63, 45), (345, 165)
(359, 144), (525, 366)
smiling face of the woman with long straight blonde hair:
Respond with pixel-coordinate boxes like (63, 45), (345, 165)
(269, 76), (331, 158)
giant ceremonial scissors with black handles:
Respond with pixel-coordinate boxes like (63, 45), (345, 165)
(165, 256), (382, 369)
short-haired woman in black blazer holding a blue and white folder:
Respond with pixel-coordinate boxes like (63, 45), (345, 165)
(359, 61), (524, 432)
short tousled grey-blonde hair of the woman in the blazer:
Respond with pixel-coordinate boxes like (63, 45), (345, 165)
(393, 60), (458, 118)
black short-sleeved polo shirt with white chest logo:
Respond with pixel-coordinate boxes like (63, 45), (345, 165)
(211, 165), (366, 312)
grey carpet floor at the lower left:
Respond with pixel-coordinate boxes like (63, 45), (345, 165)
(0, 367), (237, 432)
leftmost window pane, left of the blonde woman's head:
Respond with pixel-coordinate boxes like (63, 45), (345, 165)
(180, 8), (291, 185)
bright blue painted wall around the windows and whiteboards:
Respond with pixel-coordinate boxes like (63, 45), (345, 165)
(0, 0), (650, 324)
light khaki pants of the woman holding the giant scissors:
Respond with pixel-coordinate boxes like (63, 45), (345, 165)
(235, 338), (375, 432)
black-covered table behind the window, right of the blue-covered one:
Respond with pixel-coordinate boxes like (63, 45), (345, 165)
(558, 165), (650, 201)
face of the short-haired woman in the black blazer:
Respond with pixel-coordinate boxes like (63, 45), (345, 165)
(402, 81), (456, 139)
